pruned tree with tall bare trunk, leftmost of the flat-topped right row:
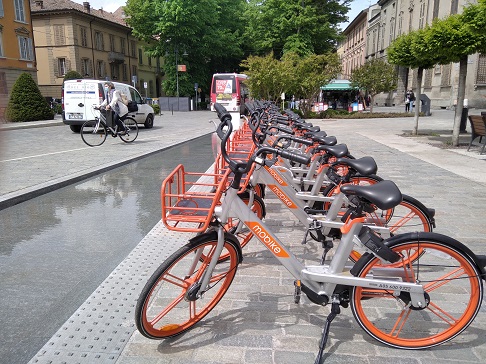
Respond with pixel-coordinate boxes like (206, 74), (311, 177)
(387, 26), (440, 135)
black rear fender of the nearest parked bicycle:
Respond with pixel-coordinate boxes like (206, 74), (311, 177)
(350, 232), (486, 280)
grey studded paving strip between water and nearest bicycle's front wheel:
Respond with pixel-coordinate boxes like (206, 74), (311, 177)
(29, 222), (194, 364)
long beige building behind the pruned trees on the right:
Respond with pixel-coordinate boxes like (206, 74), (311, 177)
(343, 0), (486, 108)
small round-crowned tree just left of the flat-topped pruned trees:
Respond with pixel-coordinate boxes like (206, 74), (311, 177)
(350, 58), (398, 112)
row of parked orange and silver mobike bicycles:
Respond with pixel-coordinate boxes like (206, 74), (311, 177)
(135, 101), (486, 363)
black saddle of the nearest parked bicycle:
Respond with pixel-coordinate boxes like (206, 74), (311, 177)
(341, 181), (402, 210)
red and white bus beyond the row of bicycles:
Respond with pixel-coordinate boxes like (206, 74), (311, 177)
(211, 73), (248, 113)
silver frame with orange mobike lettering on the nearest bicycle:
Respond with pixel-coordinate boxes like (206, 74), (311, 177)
(198, 177), (425, 307)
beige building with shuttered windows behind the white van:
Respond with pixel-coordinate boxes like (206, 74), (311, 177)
(31, 0), (160, 98)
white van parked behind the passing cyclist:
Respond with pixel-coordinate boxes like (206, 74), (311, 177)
(62, 79), (154, 133)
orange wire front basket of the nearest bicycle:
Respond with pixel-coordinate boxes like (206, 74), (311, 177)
(160, 164), (231, 233)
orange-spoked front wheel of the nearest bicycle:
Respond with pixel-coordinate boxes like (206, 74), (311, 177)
(135, 231), (242, 339)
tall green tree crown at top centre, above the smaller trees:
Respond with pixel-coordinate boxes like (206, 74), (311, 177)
(245, 0), (351, 58)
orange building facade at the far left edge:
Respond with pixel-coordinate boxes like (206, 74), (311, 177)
(0, 0), (37, 119)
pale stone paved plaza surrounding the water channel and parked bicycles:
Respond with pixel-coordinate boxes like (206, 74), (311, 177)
(0, 108), (486, 364)
